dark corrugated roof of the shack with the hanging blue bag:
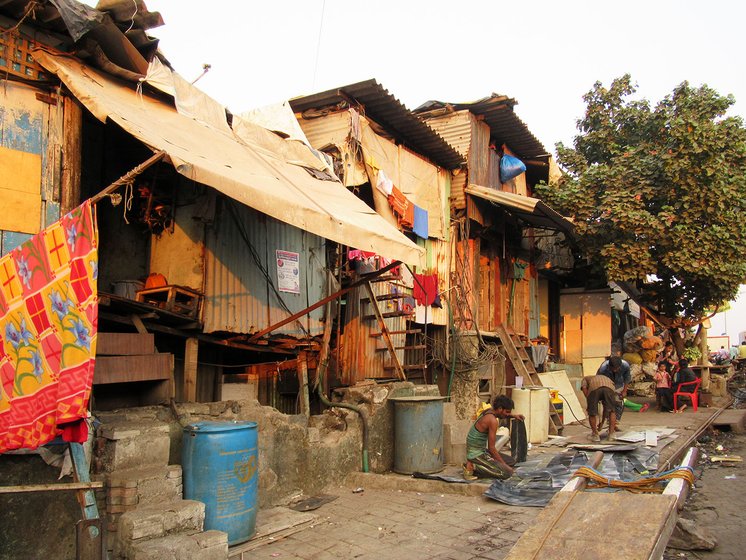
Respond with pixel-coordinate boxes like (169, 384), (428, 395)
(414, 93), (550, 160)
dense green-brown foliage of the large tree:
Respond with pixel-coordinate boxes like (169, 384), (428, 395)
(537, 75), (746, 324)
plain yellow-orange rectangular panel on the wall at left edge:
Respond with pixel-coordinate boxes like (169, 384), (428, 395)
(0, 147), (41, 233)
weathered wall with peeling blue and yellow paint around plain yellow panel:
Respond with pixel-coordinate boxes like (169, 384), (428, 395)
(0, 81), (64, 255)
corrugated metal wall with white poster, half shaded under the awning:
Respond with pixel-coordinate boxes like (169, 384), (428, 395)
(203, 199), (326, 336)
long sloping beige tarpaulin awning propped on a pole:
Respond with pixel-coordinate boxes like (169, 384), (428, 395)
(34, 51), (424, 265)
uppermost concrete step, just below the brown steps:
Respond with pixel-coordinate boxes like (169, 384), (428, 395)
(94, 420), (171, 473)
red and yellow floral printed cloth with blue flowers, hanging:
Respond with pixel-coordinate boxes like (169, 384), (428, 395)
(0, 202), (98, 453)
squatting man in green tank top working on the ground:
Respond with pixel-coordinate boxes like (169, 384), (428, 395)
(465, 395), (524, 480)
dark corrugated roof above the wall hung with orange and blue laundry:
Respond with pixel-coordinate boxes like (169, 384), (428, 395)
(290, 80), (464, 169)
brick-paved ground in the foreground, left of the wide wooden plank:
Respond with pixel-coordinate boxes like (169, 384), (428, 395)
(250, 488), (541, 560)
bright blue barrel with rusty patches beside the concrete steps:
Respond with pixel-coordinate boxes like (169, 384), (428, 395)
(181, 422), (259, 545)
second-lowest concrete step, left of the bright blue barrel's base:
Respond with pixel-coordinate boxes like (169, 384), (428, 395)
(117, 500), (205, 550)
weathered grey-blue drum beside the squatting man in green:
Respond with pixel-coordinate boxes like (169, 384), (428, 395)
(390, 397), (444, 474)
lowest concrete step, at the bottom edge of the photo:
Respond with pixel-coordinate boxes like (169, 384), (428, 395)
(126, 531), (228, 560)
